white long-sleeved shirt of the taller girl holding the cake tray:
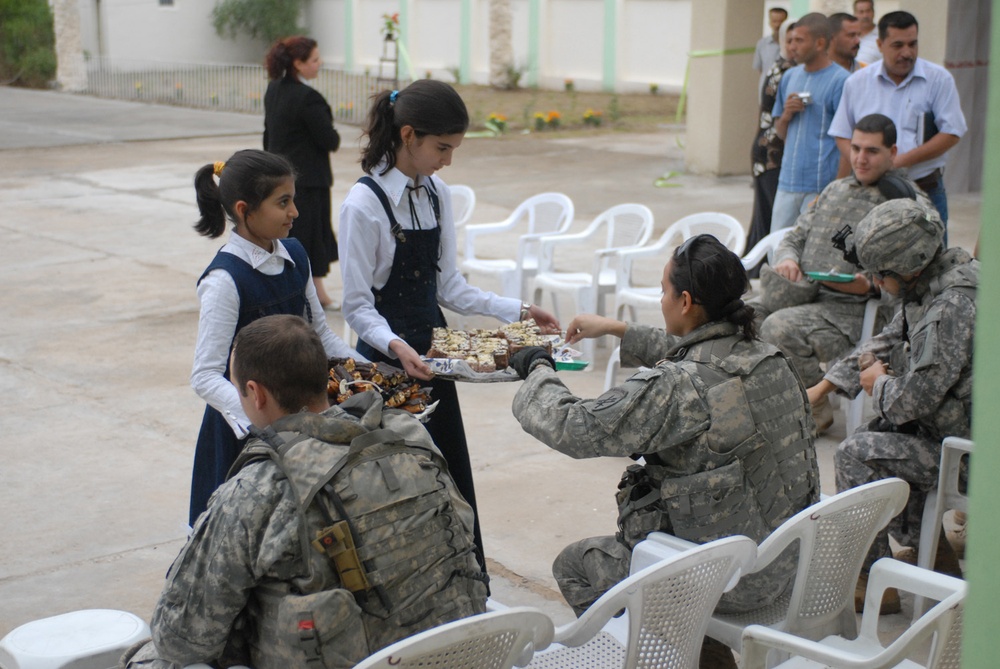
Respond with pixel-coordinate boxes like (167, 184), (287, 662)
(340, 164), (521, 358)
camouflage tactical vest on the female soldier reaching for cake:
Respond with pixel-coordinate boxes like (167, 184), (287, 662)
(618, 335), (819, 548)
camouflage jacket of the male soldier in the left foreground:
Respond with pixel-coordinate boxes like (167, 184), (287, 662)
(151, 393), (486, 669)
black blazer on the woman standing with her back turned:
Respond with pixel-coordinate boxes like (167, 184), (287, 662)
(264, 77), (340, 188)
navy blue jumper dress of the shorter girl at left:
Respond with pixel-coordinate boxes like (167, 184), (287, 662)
(188, 238), (312, 527)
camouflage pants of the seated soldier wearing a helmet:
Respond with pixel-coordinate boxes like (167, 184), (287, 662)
(833, 426), (941, 571)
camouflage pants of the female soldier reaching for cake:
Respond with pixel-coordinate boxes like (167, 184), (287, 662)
(552, 536), (798, 617)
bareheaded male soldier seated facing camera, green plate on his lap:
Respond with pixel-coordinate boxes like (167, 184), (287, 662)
(753, 114), (929, 432)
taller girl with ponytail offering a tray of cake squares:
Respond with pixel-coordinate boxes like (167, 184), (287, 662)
(340, 79), (559, 570)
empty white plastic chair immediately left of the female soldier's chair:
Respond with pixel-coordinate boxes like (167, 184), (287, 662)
(528, 537), (755, 669)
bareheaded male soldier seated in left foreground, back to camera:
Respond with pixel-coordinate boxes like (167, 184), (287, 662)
(123, 316), (486, 669)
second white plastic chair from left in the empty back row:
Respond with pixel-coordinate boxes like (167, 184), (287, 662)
(459, 193), (573, 300)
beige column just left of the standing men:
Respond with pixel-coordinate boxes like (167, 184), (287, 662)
(684, 0), (764, 175)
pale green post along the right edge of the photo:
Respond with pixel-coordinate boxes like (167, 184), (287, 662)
(962, 5), (1000, 669)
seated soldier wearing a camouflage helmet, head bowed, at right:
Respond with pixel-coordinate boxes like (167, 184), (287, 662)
(809, 200), (979, 609)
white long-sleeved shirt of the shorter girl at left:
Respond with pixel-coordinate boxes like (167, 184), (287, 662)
(191, 232), (364, 439)
